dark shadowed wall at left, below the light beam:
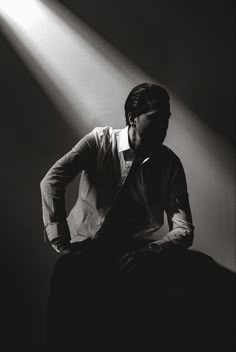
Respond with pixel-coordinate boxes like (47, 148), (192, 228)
(0, 32), (81, 352)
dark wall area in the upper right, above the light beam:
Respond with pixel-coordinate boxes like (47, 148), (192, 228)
(59, 0), (234, 140)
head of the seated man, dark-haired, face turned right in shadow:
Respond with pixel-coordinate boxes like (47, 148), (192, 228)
(125, 83), (171, 154)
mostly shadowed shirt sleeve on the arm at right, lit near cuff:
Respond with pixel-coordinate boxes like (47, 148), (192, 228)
(156, 159), (194, 248)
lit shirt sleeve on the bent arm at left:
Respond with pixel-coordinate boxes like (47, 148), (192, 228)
(40, 131), (97, 241)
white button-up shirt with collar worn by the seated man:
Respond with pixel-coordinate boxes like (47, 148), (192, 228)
(41, 127), (194, 248)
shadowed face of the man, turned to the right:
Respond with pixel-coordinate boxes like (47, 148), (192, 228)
(131, 106), (170, 152)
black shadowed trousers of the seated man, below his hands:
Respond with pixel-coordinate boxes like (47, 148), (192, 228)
(45, 240), (233, 352)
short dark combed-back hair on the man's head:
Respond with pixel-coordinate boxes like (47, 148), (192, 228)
(124, 83), (170, 125)
